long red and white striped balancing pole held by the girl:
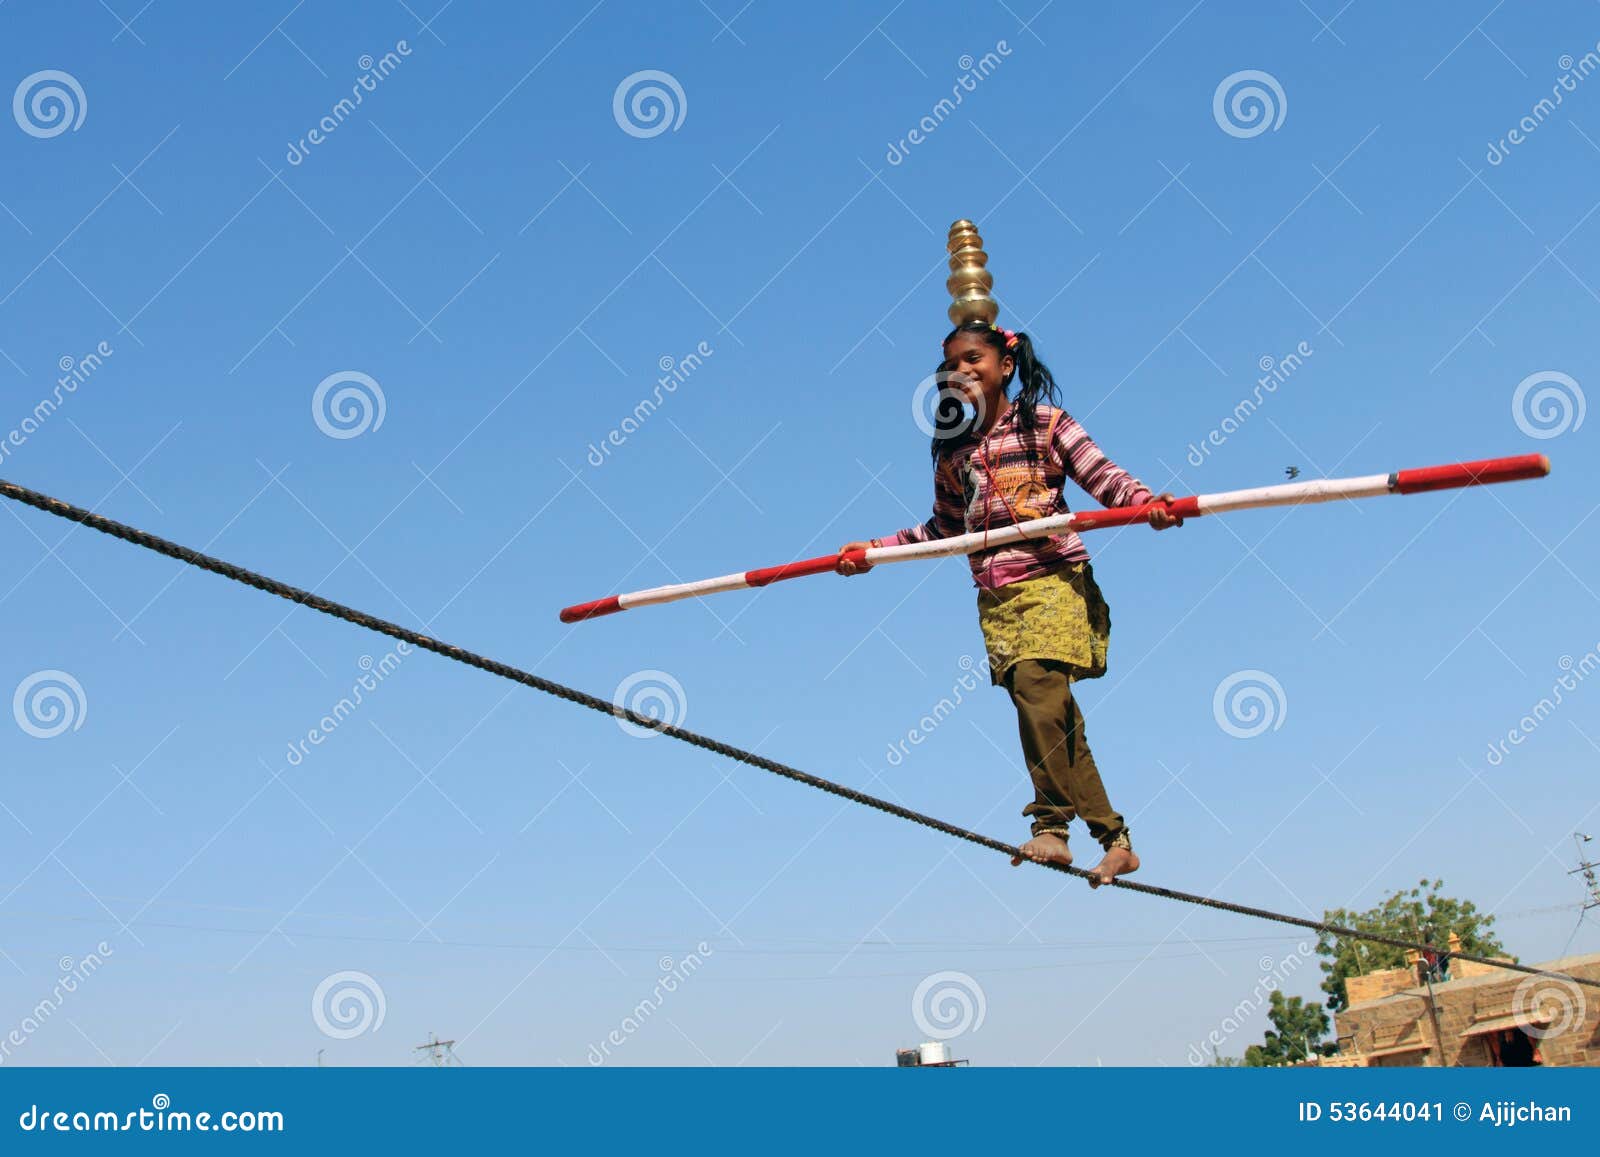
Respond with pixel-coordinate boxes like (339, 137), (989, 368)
(562, 454), (1550, 623)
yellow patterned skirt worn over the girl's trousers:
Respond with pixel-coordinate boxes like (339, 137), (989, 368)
(978, 562), (1110, 685)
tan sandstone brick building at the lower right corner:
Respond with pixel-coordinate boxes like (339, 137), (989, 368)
(1322, 936), (1600, 1067)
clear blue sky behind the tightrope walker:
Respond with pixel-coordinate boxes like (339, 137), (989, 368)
(0, 0), (1600, 1066)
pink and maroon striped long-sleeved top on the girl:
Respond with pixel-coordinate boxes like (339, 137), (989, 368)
(883, 405), (1152, 591)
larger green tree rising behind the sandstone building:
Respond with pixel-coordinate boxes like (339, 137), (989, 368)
(1317, 880), (1506, 1011)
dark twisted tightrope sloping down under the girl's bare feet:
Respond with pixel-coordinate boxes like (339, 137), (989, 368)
(0, 480), (1600, 987)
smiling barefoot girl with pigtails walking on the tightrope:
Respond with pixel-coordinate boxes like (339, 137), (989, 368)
(838, 322), (1182, 888)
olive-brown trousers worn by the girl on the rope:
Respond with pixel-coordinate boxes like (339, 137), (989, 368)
(1005, 659), (1128, 848)
